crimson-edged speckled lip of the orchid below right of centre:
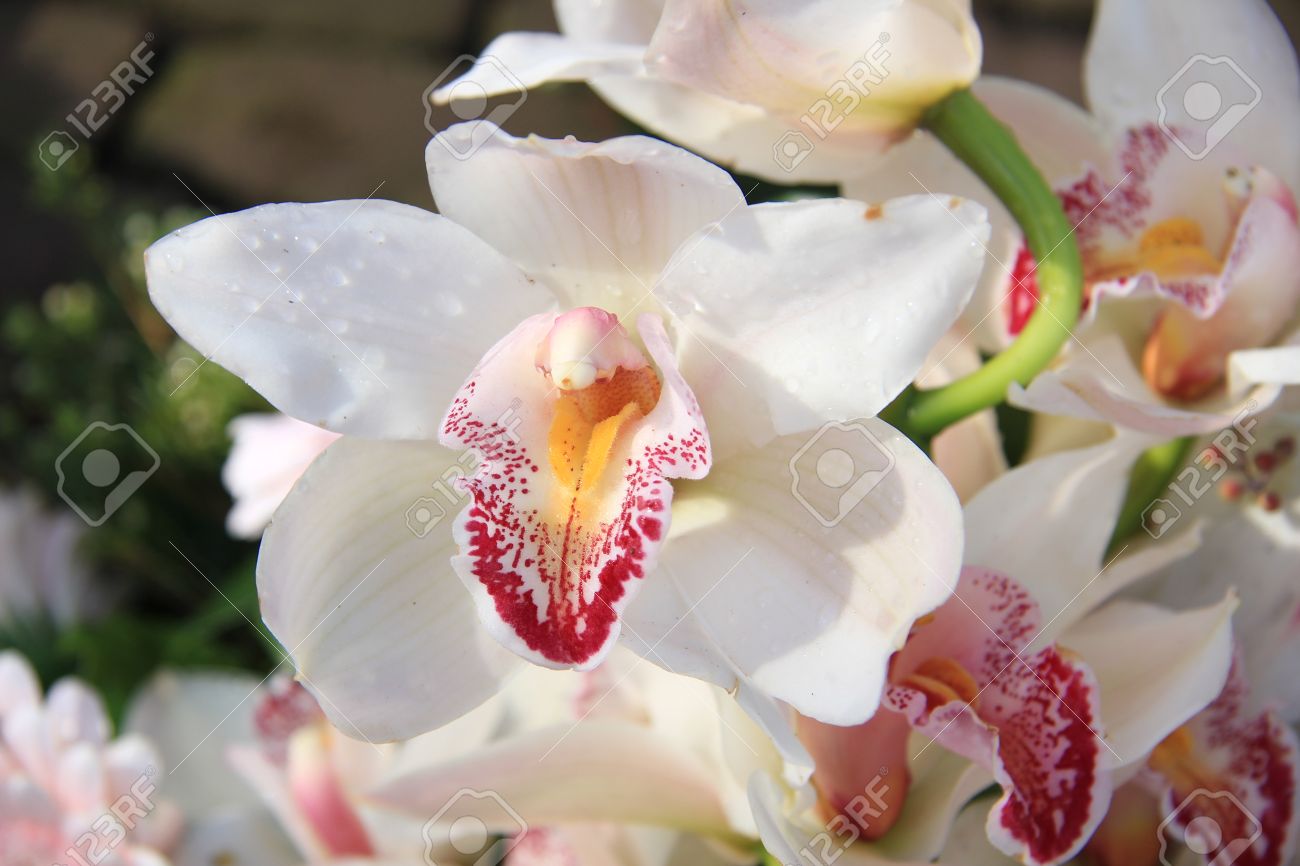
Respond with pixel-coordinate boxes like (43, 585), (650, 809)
(885, 568), (1110, 863)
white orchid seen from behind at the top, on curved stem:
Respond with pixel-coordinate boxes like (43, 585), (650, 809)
(433, 0), (982, 183)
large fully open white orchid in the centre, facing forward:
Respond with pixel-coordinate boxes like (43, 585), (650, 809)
(147, 122), (985, 740)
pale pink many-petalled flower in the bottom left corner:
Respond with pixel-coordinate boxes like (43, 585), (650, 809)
(0, 651), (181, 866)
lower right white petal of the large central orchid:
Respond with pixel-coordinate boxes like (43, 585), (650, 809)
(624, 419), (961, 724)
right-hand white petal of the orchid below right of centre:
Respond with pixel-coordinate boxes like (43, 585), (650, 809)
(1061, 596), (1236, 765)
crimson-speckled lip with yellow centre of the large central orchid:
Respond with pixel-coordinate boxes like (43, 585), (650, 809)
(442, 315), (711, 668)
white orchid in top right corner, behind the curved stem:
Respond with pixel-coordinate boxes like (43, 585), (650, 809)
(863, 0), (1300, 436)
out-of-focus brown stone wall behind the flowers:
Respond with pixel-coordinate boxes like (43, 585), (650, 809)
(10, 0), (1300, 207)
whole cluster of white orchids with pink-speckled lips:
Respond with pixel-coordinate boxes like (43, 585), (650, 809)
(0, 0), (1300, 866)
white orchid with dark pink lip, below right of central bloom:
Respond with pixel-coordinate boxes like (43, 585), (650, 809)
(751, 437), (1236, 863)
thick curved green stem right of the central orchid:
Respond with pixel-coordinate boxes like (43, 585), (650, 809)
(892, 90), (1083, 441)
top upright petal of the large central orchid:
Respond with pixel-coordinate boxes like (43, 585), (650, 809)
(425, 121), (745, 312)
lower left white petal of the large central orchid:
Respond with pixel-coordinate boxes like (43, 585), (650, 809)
(257, 437), (515, 741)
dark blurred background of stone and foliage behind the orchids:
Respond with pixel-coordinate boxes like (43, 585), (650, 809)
(0, 0), (1300, 709)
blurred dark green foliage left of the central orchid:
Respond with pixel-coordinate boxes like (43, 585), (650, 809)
(0, 146), (281, 714)
